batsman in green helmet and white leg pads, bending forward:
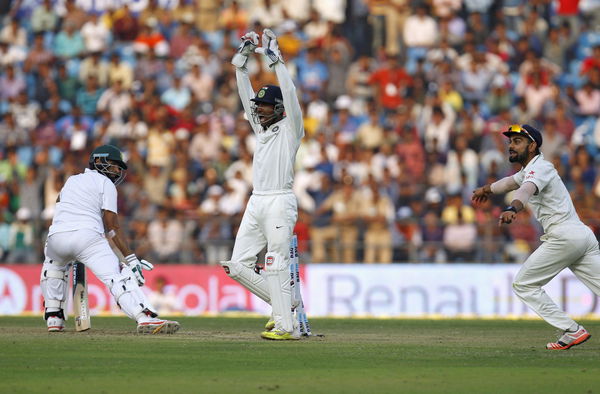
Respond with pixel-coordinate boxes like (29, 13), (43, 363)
(40, 145), (179, 334)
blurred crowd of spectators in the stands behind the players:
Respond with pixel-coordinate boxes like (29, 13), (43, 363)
(0, 0), (600, 264)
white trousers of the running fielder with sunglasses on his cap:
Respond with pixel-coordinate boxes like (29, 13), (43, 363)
(513, 224), (600, 330)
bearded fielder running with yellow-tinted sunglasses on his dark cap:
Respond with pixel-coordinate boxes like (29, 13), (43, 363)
(472, 124), (600, 350)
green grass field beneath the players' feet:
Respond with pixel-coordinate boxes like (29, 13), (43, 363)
(0, 317), (600, 393)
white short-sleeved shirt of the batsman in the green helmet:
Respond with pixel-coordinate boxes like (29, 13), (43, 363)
(48, 168), (117, 235)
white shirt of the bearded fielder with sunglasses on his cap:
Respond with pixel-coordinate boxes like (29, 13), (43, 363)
(513, 153), (583, 233)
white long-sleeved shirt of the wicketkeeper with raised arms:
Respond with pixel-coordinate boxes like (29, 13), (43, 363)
(235, 63), (304, 194)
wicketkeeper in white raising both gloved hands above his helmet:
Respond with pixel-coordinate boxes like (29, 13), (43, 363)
(221, 29), (304, 340)
